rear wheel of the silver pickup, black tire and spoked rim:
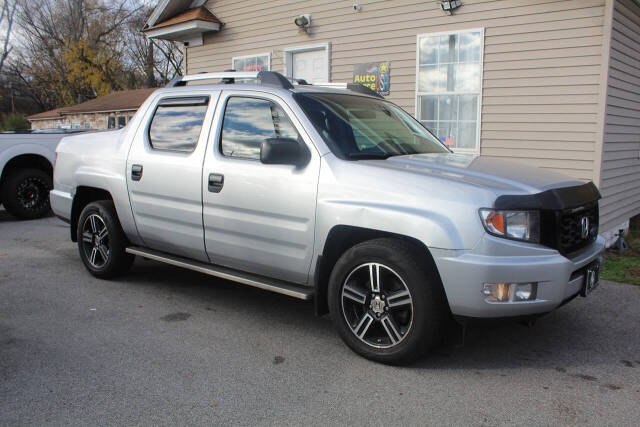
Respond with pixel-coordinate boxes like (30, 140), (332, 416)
(76, 200), (135, 279)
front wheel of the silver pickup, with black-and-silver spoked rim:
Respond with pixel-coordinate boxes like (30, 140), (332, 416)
(329, 238), (448, 364)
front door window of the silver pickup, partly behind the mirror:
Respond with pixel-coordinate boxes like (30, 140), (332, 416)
(221, 97), (299, 160)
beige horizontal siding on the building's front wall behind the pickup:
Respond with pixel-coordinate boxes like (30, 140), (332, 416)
(187, 0), (604, 180)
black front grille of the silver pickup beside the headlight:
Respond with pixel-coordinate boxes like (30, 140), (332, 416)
(556, 203), (599, 254)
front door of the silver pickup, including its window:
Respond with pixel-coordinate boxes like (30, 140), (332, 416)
(203, 91), (320, 283)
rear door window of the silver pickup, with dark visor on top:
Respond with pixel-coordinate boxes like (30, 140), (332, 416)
(149, 96), (209, 152)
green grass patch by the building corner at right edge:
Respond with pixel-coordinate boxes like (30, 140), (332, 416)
(600, 216), (640, 285)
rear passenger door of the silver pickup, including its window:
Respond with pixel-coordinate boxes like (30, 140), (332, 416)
(127, 91), (220, 262)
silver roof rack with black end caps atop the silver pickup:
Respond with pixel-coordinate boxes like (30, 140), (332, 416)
(167, 70), (383, 98)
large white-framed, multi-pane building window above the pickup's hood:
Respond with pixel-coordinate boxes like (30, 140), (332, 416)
(416, 29), (484, 152)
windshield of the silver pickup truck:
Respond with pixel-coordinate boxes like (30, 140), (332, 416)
(294, 93), (449, 160)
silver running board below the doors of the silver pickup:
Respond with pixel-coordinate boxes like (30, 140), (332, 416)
(126, 247), (313, 300)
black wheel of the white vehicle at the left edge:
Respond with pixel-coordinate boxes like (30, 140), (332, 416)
(0, 169), (53, 219)
